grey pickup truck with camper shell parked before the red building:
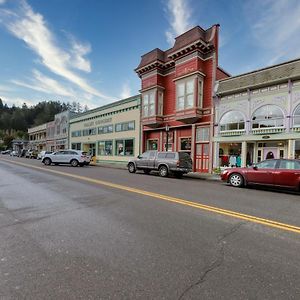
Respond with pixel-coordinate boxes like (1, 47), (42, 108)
(127, 151), (192, 178)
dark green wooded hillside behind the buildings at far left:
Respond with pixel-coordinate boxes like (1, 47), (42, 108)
(0, 99), (88, 149)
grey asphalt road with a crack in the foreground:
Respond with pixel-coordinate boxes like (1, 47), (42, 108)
(0, 156), (300, 300)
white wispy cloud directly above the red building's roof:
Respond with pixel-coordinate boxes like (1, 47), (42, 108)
(166, 0), (193, 45)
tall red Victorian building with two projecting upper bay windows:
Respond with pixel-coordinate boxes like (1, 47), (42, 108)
(135, 25), (229, 172)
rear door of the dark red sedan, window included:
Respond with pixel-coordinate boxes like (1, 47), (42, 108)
(273, 159), (300, 188)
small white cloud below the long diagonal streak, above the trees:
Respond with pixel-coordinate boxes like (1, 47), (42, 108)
(11, 70), (76, 98)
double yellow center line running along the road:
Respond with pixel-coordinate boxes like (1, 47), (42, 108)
(1, 158), (300, 234)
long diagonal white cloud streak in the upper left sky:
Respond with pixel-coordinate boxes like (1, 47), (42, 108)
(0, 0), (114, 101)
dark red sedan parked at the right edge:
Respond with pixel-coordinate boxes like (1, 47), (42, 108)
(221, 159), (300, 190)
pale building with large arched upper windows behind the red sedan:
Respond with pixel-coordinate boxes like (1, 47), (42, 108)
(214, 59), (300, 167)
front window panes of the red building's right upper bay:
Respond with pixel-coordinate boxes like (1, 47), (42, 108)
(176, 78), (195, 110)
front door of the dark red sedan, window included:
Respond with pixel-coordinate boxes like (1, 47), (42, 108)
(246, 159), (277, 185)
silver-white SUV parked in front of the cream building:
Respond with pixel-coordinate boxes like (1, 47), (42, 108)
(42, 149), (91, 167)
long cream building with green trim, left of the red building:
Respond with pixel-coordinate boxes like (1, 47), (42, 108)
(69, 95), (140, 163)
